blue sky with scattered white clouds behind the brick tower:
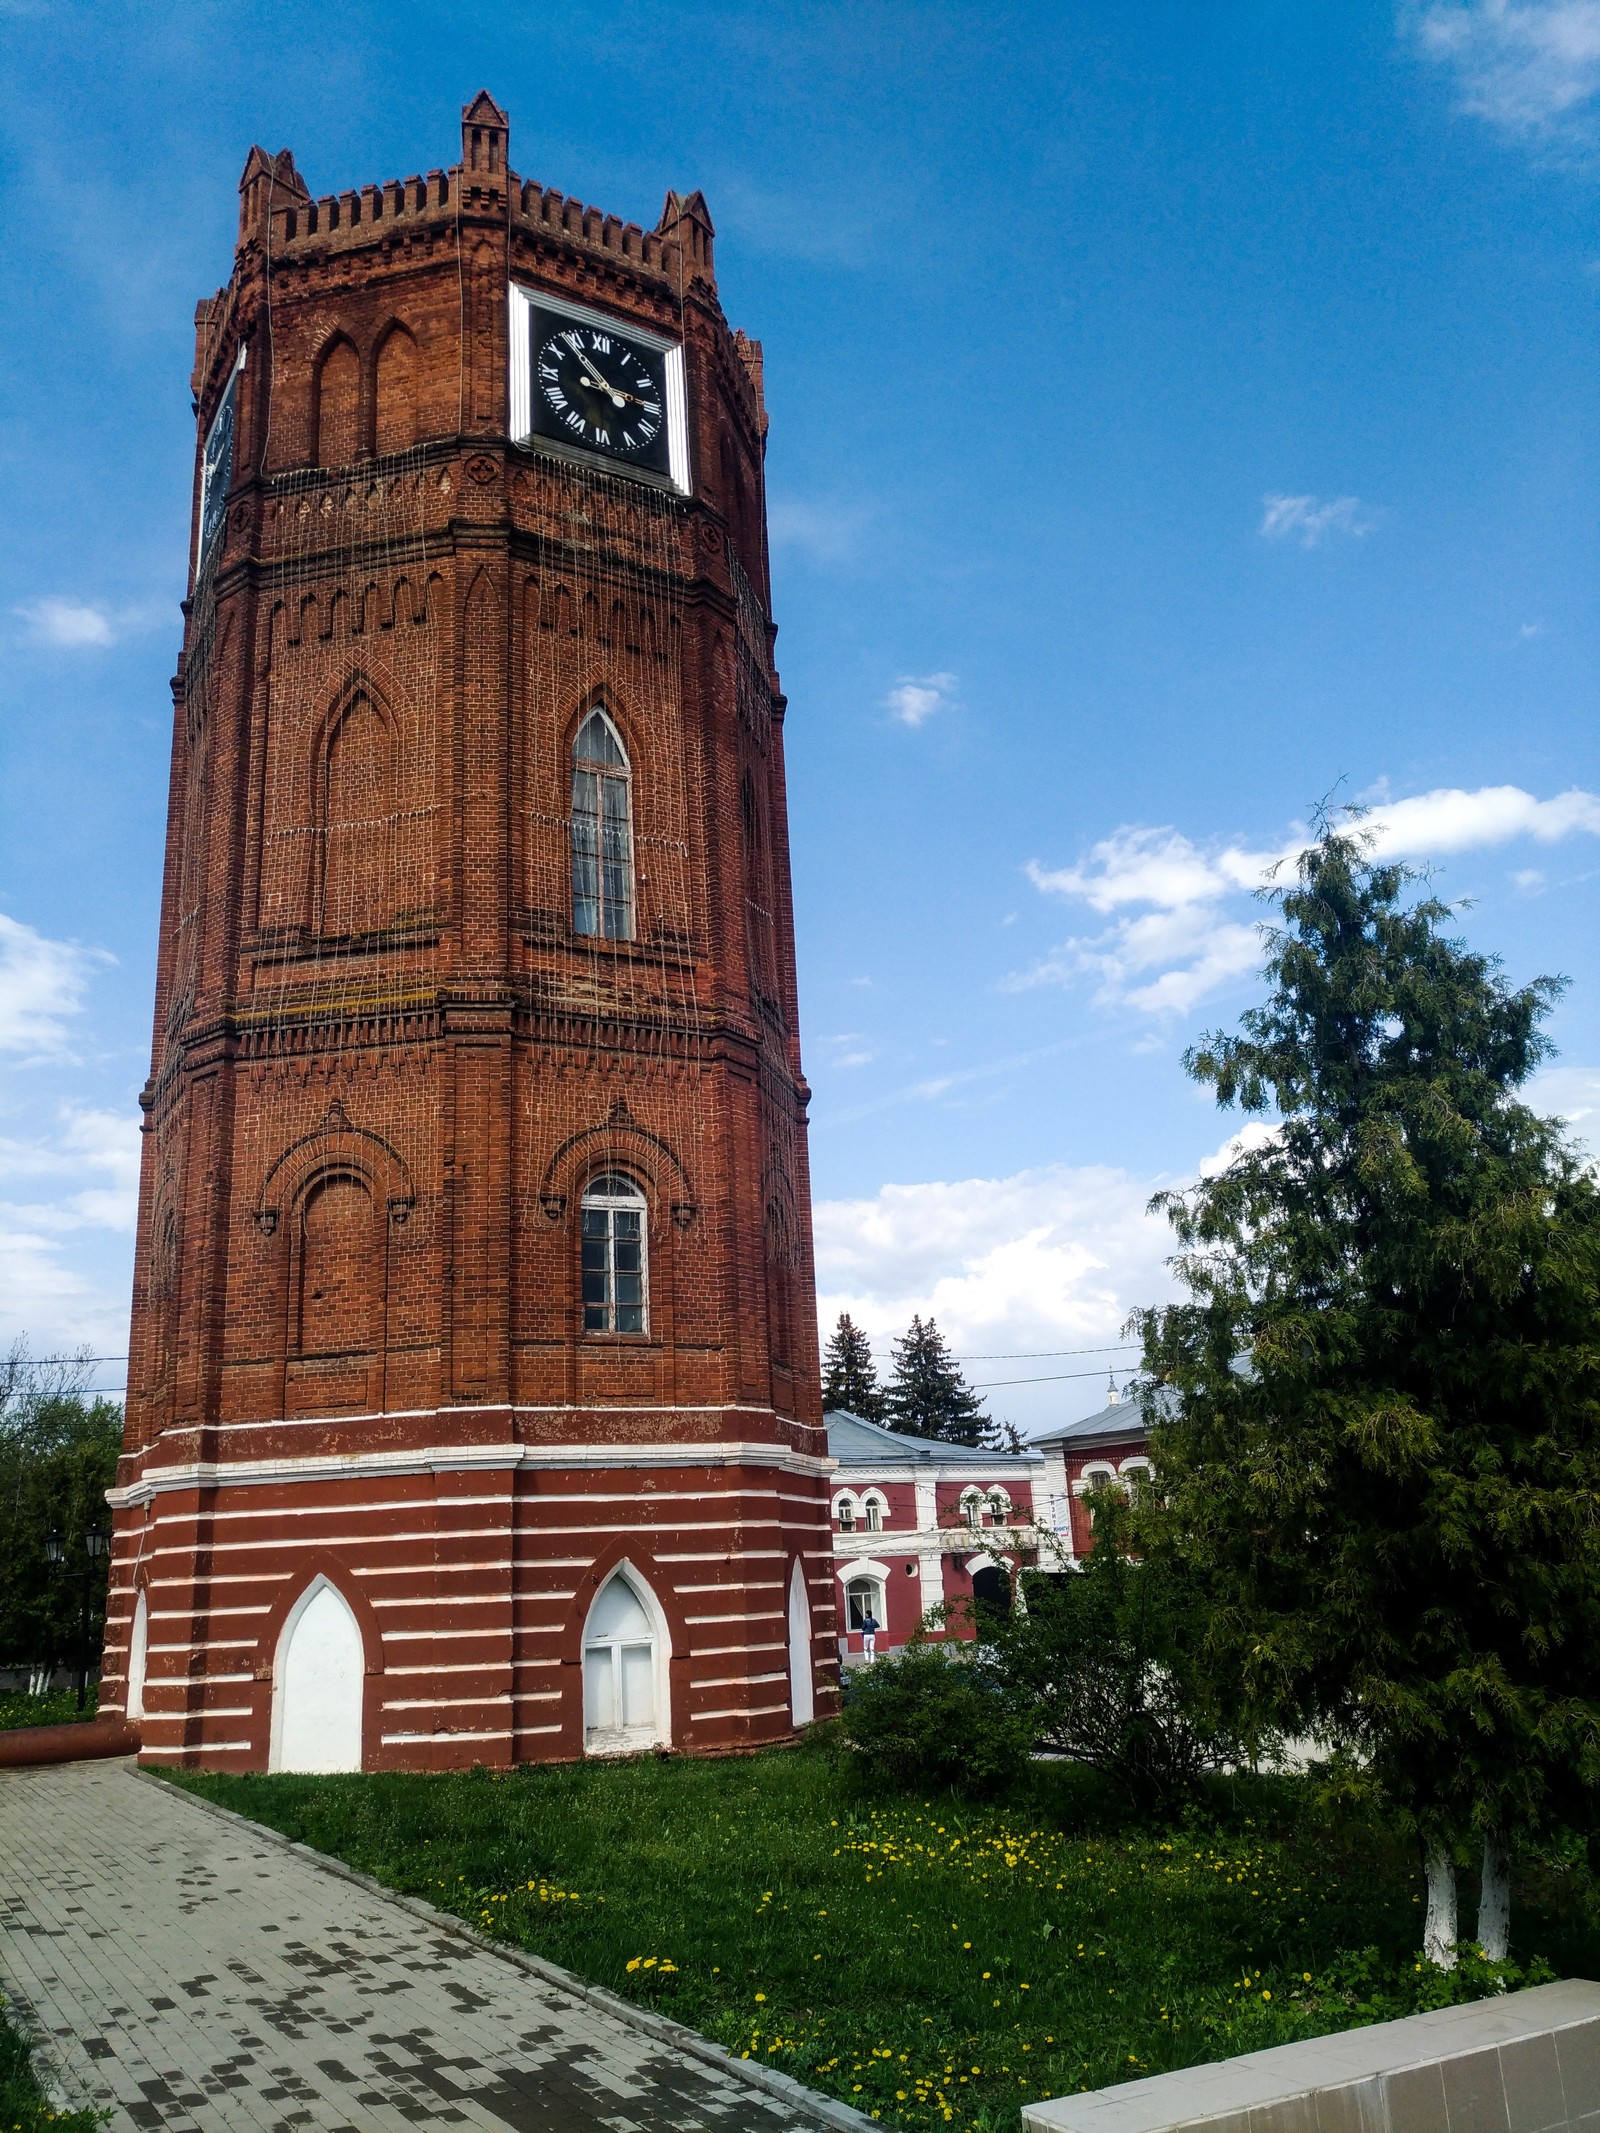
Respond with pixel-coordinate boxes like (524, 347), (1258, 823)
(0, 0), (1600, 1427)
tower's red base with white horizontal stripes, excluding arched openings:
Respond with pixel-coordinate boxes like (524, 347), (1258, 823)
(100, 1410), (838, 1770)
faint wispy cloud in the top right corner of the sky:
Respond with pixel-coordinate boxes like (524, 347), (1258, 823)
(1406, 0), (1600, 137)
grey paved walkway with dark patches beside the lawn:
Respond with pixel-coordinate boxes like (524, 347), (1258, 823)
(0, 1762), (864, 2133)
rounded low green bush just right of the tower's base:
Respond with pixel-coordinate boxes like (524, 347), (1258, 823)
(843, 1642), (1030, 1796)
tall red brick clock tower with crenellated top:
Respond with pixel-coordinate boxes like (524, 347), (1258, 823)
(102, 94), (836, 1768)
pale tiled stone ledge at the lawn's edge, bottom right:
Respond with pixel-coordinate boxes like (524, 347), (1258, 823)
(1022, 1977), (1600, 2133)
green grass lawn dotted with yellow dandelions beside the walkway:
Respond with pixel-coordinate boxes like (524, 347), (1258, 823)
(177, 1751), (1600, 2133)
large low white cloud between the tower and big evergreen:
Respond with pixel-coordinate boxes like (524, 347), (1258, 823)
(813, 1165), (1173, 1429)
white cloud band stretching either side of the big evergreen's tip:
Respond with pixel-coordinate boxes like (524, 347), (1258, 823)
(1019, 785), (1600, 1015)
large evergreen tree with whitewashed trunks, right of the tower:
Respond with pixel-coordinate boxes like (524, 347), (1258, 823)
(1135, 828), (1600, 1964)
